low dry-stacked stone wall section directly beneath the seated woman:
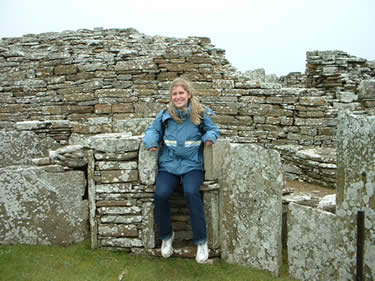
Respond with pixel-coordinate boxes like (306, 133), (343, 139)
(87, 134), (220, 257)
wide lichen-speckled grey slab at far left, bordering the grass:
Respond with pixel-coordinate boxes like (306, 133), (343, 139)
(0, 166), (88, 245)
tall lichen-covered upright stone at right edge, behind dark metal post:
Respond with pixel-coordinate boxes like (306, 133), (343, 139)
(336, 112), (375, 280)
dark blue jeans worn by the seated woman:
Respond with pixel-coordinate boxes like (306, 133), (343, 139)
(155, 170), (207, 245)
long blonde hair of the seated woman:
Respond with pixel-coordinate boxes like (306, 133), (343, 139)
(168, 78), (204, 125)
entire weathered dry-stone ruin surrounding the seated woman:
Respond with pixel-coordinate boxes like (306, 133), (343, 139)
(0, 29), (375, 280)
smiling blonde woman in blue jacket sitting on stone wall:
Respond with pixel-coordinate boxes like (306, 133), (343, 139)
(143, 78), (220, 263)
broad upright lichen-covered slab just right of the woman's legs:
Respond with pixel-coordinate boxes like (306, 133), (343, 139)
(219, 143), (283, 275)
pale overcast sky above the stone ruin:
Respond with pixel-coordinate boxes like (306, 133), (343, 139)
(0, 0), (375, 76)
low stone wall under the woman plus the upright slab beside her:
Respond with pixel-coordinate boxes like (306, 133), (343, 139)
(88, 134), (283, 275)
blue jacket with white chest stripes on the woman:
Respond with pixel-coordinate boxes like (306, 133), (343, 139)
(143, 106), (220, 175)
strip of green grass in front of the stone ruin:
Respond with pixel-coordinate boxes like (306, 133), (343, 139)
(0, 240), (293, 281)
